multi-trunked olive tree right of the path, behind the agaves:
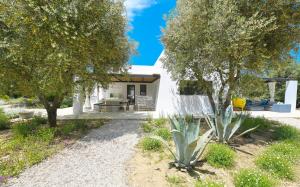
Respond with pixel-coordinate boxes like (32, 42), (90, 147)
(162, 0), (300, 142)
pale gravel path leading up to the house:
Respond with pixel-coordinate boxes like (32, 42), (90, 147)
(6, 120), (139, 187)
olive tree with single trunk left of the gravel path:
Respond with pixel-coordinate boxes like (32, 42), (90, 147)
(0, 0), (131, 127)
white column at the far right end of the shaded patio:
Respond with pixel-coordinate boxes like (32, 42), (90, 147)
(284, 80), (298, 112)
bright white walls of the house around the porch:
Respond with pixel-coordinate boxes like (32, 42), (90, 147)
(74, 53), (211, 116)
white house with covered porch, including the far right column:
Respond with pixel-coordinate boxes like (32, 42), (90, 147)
(73, 53), (297, 116)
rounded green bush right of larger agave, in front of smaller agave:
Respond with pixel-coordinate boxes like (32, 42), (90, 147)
(205, 144), (235, 168)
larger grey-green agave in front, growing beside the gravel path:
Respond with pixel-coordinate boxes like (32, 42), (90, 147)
(152, 117), (213, 169)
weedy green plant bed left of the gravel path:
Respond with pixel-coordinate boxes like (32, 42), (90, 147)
(0, 117), (104, 185)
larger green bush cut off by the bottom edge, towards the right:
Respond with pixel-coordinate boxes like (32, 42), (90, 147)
(234, 169), (275, 187)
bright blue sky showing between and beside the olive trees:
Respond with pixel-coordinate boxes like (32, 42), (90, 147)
(125, 0), (300, 65)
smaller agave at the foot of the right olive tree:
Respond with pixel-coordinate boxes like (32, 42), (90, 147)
(205, 105), (258, 143)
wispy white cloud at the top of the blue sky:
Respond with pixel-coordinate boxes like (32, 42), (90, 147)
(125, 0), (156, 20)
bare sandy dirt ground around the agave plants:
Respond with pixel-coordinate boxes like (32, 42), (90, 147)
(127, 133), (300, 187)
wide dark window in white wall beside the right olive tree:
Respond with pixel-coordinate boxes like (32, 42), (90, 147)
(179, 80), (204, 95)
